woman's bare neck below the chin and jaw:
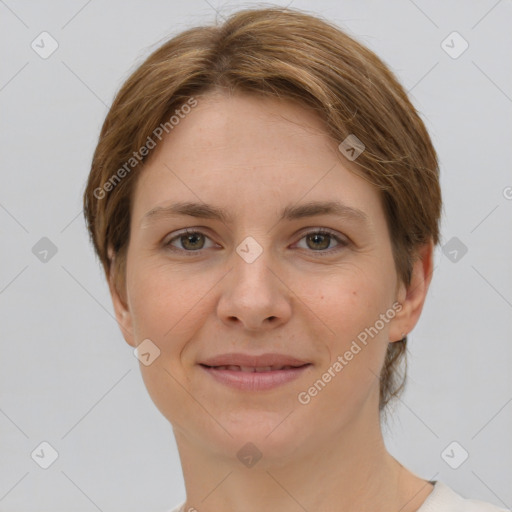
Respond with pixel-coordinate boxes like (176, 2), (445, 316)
(174, 398), (432, 512)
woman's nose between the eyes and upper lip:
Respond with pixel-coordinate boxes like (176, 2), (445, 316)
(217, 244), (293, 331)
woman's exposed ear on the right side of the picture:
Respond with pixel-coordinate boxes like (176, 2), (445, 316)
(389, 241), (434, 342)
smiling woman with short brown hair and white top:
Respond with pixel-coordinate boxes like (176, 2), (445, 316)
(84, 8), (508, 512)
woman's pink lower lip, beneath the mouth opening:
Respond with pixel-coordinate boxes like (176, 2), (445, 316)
(200, 364), (311, 391)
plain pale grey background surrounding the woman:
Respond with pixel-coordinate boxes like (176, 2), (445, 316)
(0, 0), (512, 512)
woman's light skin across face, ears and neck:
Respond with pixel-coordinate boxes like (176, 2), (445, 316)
(110, 93), (433, 512)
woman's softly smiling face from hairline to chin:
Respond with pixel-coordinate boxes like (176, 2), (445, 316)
(114, 94), (420, 460)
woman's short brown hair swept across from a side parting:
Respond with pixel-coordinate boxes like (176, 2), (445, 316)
(84, 7), (441, 410)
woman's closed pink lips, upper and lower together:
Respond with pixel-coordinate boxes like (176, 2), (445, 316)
(199, 354), (312, 391)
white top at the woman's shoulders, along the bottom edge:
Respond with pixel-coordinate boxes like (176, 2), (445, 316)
(168, 481), (511, 512)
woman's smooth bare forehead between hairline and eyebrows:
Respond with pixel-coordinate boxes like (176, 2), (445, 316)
(130, 94), (379, 226)
